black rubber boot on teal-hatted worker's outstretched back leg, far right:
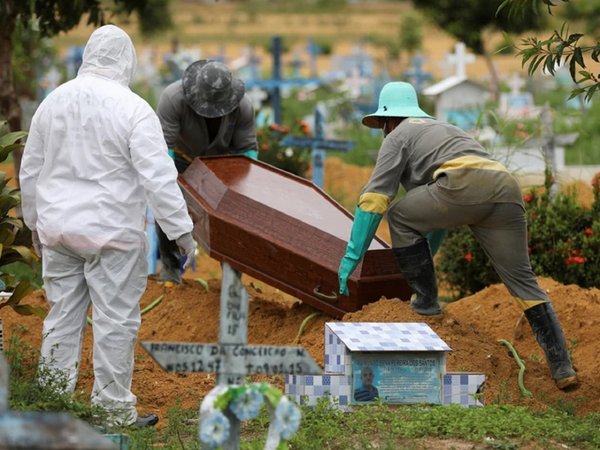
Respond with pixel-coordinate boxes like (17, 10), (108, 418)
(525, 302), (578, 389)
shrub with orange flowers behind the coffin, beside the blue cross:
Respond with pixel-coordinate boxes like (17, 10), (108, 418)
(256, 119), (311, 177)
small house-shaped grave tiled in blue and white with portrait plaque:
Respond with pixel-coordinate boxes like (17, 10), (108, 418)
(285, 322), (485, 410)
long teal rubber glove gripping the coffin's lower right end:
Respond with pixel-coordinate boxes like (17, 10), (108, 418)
(338, 208), (383, 295)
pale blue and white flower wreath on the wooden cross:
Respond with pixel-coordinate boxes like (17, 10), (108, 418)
(199, 383), (301, 450)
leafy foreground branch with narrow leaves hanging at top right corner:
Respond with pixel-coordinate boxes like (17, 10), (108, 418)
(498, 0), (600, 100)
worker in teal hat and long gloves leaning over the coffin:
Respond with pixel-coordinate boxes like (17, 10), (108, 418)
(338, 82), (578, 390)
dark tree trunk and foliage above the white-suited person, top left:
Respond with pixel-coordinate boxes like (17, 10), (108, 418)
(0, 0), (171, 179)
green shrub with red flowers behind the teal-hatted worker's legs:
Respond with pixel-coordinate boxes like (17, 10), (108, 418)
(437, 171), (600, 296)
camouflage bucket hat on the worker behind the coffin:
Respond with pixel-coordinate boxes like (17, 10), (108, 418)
(182, 59), (246, 117)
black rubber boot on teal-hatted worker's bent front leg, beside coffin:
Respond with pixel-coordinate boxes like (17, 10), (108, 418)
(394, 239), (442, 316)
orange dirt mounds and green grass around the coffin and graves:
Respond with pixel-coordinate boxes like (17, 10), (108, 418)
(0, 158), (600, 449)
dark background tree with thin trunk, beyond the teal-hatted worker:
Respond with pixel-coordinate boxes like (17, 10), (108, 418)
(413, 0), (549, 96)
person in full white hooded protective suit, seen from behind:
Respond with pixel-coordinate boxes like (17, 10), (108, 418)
(19, 25), (196, 426)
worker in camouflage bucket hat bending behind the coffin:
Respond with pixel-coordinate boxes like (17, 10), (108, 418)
(156, 59), (258, 286)
